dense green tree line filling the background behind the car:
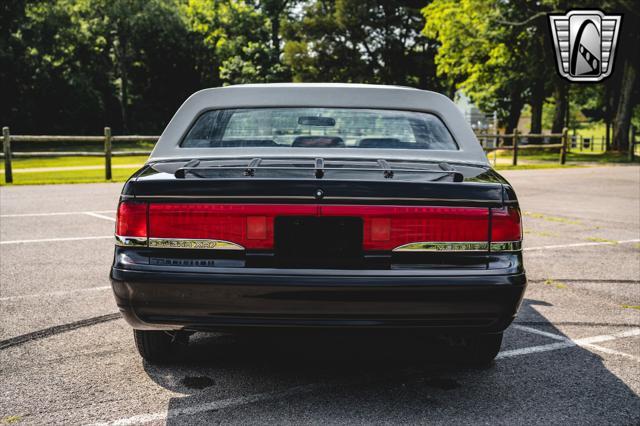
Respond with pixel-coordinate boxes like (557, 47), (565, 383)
(0, 0), (640, 138)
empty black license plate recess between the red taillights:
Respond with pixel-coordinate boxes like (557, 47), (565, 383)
(274, 216), (363, 266)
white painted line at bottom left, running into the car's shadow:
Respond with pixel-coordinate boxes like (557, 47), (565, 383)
(88, 384), (319, 426)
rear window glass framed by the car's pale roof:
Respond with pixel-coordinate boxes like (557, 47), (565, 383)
(180, 108), (458, 150)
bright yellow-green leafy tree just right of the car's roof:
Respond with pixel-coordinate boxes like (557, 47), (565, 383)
(422, 0), (530, 133)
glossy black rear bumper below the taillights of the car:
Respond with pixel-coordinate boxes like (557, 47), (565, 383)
(111, 267), (526, 332)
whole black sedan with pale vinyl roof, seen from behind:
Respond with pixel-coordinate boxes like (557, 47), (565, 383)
(111, 84), (526, 364)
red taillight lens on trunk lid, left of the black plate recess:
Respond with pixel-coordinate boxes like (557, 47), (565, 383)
(149, 203), (317, 249)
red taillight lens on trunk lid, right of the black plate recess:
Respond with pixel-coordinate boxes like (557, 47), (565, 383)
(320, 206), (489, 250)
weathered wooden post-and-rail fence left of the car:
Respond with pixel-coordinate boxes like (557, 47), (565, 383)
(2, 127), (159, 183)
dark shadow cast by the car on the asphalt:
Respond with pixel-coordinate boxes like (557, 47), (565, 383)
(145, 300), (640, 424)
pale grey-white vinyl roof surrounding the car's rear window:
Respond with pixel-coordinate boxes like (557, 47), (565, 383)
(147, 83), (489, 165)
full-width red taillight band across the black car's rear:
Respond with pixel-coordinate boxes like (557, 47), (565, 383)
(116, 201), (522, 251)
